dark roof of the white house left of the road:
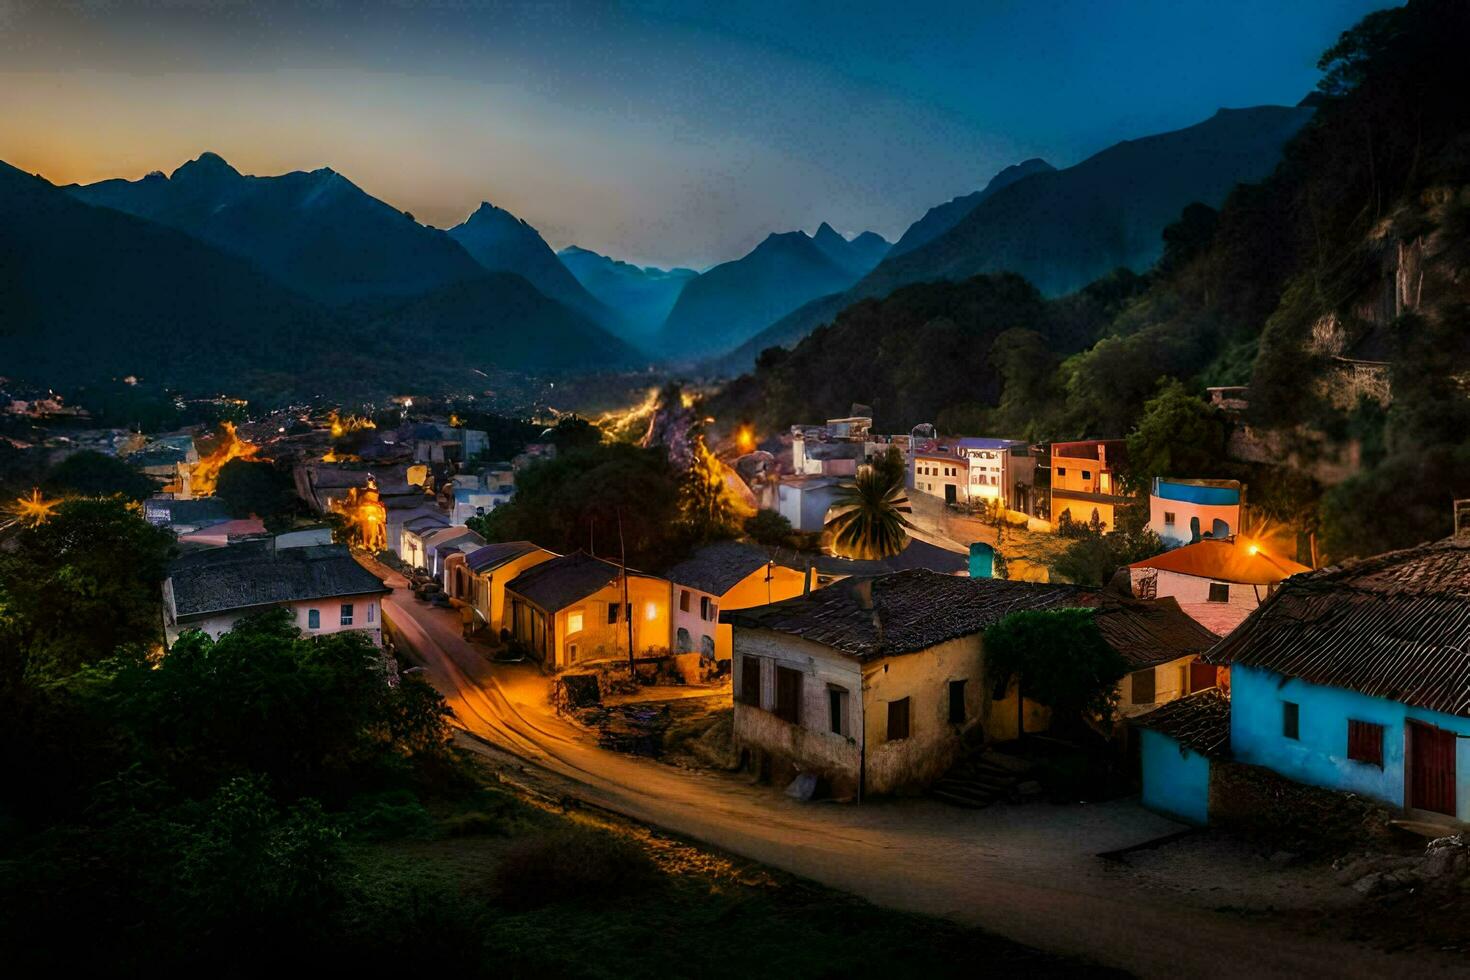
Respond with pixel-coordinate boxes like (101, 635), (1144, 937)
(169, 542), (388, 620)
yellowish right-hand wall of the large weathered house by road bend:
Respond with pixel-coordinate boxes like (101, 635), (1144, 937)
(863, 635), (985, 795)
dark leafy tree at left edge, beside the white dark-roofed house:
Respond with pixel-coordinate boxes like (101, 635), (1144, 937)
(0, 498), (173, 680)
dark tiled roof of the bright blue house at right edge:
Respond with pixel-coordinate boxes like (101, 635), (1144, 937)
(1208, 539), (1470, 717)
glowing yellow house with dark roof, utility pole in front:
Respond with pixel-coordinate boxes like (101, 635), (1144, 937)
(506, 551), (672, 670)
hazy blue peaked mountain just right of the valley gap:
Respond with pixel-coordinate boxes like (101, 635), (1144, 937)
(657, 222), (888, 360)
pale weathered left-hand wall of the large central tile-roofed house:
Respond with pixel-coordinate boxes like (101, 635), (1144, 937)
(732, 629), (864, 796)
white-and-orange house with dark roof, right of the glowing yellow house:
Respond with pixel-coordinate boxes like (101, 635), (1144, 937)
(664, 541), (816, 661)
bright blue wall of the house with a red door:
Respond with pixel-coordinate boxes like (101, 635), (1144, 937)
(1230, 664), (1470, 821)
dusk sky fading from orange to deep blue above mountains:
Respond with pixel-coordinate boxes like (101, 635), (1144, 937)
(0, 0), (1388, 267)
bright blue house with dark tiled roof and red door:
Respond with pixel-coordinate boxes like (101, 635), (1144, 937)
(1208, 538), (1470, 821)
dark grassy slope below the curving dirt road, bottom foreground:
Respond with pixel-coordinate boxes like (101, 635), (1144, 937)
(338, 769), (1128, 980)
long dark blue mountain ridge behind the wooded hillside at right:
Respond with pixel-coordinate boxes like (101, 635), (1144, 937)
(722, 106), (1313, 372)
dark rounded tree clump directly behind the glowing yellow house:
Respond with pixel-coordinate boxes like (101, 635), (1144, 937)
(472, 444), (685, 567)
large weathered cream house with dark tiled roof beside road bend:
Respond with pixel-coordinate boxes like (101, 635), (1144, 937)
(720, 570), (1089, 798)
